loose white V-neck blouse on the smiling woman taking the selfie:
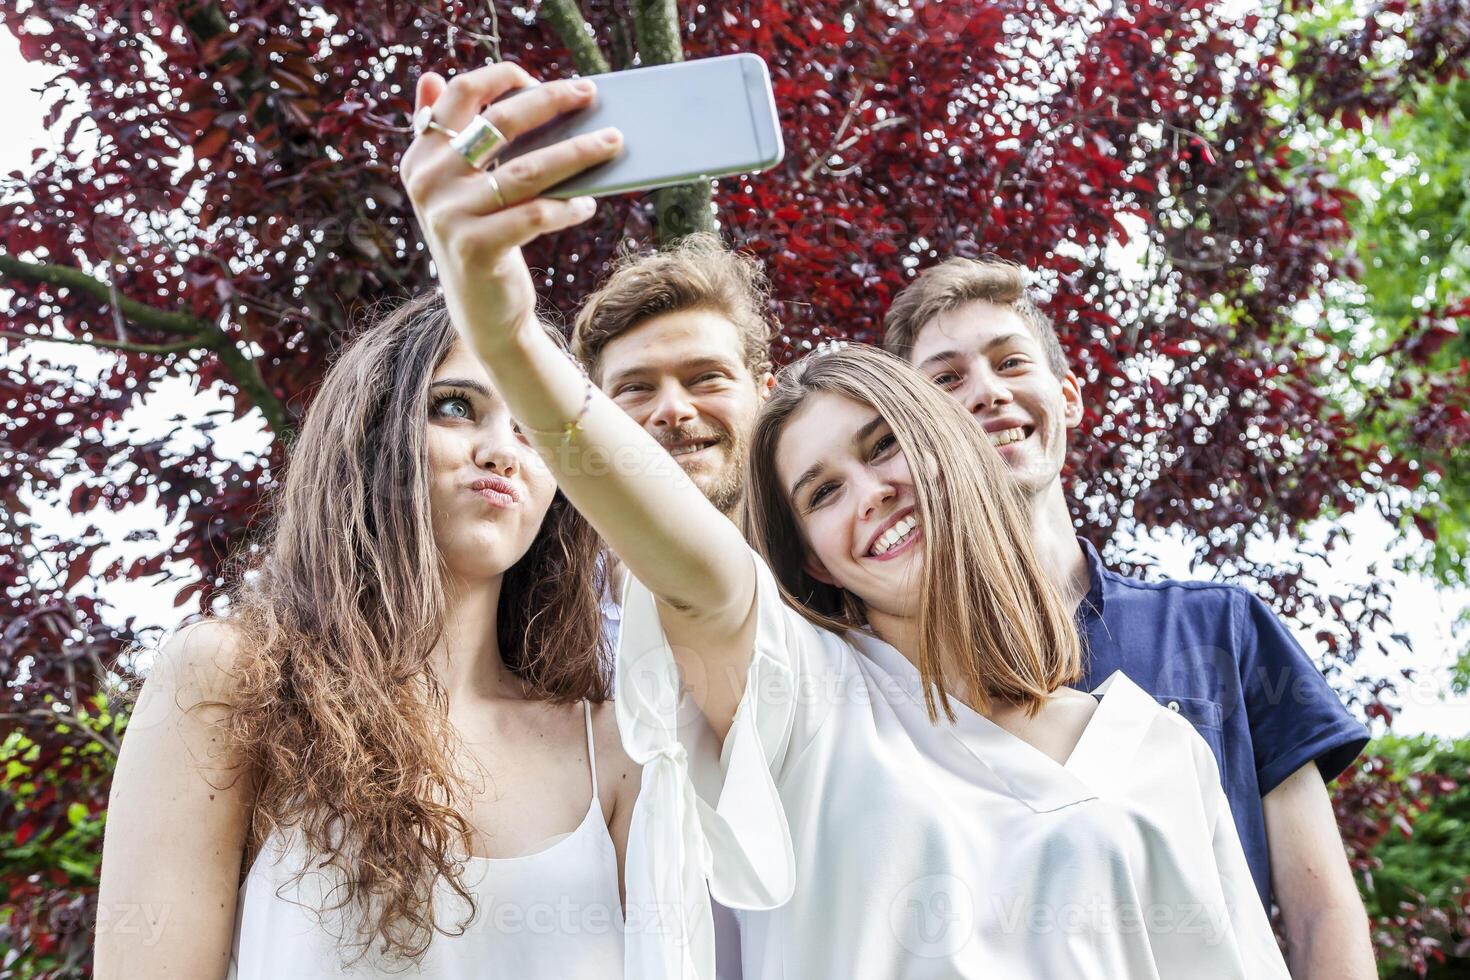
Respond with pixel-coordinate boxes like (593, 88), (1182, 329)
(616, 551), (1288, 980)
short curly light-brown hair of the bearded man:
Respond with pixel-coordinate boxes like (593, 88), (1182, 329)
(572, 232), (775, 383)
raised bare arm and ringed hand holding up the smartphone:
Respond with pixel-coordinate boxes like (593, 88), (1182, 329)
(401, 65), (756, 735)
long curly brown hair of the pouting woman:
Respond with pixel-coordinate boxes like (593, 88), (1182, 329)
(210, 292), (610, 959)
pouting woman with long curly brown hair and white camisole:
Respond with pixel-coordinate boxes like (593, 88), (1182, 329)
(96, 294), (638, 980)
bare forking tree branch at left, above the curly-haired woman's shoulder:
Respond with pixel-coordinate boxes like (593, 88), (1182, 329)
(0, 253), (295, 441)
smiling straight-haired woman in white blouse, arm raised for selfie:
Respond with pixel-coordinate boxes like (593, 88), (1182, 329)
(401, 59), (1286, 980)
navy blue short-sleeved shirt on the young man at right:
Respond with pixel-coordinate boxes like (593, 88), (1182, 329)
(1078, 538), (1369, 911)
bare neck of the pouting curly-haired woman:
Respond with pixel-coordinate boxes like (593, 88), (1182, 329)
(434, 576), (526, 704)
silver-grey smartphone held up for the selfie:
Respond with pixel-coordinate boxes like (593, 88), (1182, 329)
(497, 53), (785, 198)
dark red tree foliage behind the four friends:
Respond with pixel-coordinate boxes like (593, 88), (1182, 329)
(0, 0), (1467, 975)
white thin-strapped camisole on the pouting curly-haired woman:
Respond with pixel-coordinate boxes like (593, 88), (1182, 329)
(229, 701), (623, 980)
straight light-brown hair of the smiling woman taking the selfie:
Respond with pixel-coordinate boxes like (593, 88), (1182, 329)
(744, 344), (1082, 721)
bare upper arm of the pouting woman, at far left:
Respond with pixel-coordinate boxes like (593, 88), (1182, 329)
(96, 623), (251, 980)
